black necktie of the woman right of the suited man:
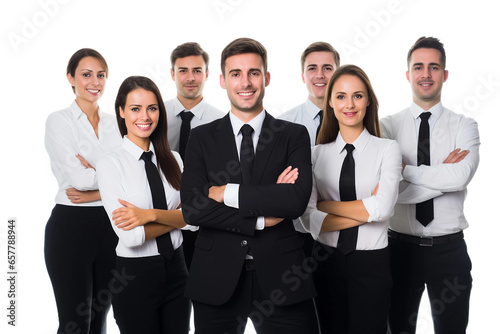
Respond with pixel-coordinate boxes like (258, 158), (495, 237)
(337, 144), (358, 255)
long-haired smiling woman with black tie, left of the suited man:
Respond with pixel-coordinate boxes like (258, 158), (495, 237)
(97, 76), (190, 334)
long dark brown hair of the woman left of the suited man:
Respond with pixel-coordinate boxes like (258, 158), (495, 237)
(115, 76), (181, 190)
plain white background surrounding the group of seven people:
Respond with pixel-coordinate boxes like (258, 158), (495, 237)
(0, 0), (500, 333)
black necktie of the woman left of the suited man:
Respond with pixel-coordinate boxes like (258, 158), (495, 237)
(141, 151), (174, 259)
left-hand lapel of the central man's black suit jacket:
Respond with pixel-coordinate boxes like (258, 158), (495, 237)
(215, 113), (243, 184)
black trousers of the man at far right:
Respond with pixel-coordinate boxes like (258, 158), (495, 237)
(389, 238), (472, 334)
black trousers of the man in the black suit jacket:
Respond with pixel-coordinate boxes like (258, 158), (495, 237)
(193, 262), (318, 334)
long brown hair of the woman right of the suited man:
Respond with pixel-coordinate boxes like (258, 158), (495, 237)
(316, 65), (381, 144)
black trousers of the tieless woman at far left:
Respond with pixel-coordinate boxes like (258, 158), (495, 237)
(44, 204), (118, 334)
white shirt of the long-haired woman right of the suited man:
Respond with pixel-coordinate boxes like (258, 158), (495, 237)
(300, 129), (401, 250)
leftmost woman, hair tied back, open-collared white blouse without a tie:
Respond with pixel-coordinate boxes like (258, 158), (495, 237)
(45, 49), (120, 334)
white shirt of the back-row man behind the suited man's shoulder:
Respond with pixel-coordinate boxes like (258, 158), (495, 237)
(278, 98), (321, 146)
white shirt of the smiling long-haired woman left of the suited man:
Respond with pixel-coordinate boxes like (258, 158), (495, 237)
(97, 136), (183, 257)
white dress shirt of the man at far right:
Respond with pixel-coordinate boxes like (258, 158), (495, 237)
(381, 103), (480, 236)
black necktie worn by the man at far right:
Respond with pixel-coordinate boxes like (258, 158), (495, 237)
(415, 112), (434, 226)
